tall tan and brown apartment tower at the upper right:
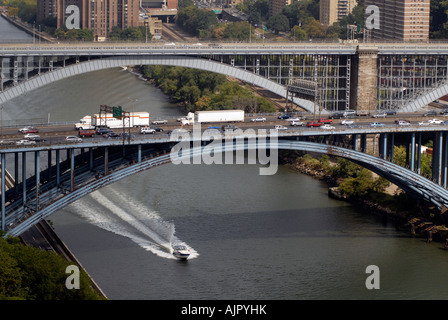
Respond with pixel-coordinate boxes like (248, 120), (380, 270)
(365, 0), (430, 42)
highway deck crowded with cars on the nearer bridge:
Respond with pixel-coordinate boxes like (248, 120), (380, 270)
(0, 111), (448, 149)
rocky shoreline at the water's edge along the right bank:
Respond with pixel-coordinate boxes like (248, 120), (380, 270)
(280, 152), (448, 245)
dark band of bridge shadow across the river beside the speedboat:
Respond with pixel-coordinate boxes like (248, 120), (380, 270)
(163, 206), (409, 241)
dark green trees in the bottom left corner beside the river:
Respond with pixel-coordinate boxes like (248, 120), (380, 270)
(0, 237), (102, 300)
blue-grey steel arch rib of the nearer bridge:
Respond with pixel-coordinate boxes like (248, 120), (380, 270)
(5, 140), (448, 236)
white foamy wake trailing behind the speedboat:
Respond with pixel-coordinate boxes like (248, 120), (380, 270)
(69, 187), (199, 259)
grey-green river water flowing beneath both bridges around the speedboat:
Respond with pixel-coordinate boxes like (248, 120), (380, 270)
(0, 19), (448, 300)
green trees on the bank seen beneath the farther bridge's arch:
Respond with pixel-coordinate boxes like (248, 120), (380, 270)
(140, 65), (276, 113)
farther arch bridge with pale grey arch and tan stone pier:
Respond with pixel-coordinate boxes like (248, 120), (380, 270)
(0, 43), (448, 113)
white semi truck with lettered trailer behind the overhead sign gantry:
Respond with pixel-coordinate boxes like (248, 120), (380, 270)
(75, 112), (149, 130)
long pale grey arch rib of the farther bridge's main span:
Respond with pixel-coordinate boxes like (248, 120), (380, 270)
(0, 55), (316, 112)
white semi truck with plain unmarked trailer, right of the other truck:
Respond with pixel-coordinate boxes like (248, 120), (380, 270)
(181, 110), (244, 125)
